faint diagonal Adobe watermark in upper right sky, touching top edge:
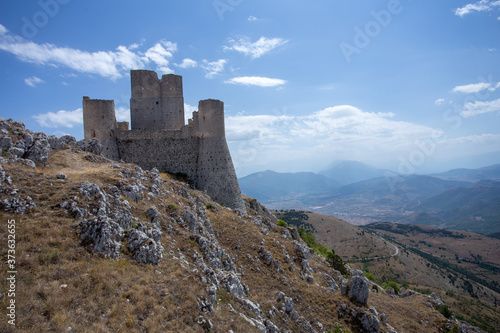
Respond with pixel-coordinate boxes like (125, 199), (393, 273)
(339, 0), (403, 63)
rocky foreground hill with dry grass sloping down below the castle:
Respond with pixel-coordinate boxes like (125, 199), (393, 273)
(0, 119), (480, 332)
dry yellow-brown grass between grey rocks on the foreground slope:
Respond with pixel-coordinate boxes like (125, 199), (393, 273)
(0, 148), (468, 333)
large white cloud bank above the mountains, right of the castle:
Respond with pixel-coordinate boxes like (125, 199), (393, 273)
(226, 105), (441, 173)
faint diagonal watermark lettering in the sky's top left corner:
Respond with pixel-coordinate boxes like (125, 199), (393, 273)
(21, 0), (71, 38)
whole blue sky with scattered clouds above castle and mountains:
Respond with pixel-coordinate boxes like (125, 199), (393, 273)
(0, 0), (500, 176)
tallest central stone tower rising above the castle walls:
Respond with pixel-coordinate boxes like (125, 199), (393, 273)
(130, 70), (184, 130)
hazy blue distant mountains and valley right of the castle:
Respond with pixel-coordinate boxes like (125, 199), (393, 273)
(240, 161), (500, 234)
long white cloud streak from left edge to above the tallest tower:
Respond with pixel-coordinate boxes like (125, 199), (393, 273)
(0, 26), (177, 80)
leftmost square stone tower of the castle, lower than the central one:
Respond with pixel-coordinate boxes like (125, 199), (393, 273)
(83, 96), (120, 160)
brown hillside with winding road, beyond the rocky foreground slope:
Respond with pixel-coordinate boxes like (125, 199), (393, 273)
(273, 210), (500, 332)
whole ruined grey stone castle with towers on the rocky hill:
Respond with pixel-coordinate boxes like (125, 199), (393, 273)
(83, 70), (246, 212)
